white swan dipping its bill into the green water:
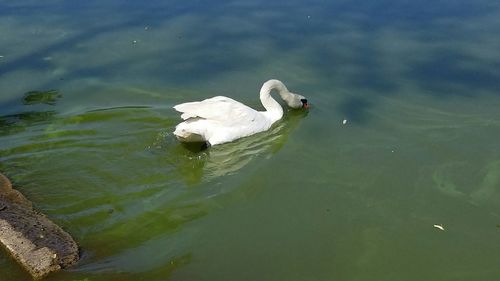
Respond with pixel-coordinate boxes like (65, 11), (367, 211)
(174, 79), (308, 146)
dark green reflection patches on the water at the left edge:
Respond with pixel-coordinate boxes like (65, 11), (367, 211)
(0, 90), (61, 136)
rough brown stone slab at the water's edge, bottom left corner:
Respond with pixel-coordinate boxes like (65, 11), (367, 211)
(0, 173), (79, 279)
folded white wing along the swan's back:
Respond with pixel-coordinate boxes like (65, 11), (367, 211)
(174, 96), (259, 122)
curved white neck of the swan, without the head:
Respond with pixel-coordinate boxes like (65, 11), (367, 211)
(260, 79), (290, 123)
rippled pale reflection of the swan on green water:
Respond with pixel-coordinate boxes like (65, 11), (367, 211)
(173, 110), (307, 184)
